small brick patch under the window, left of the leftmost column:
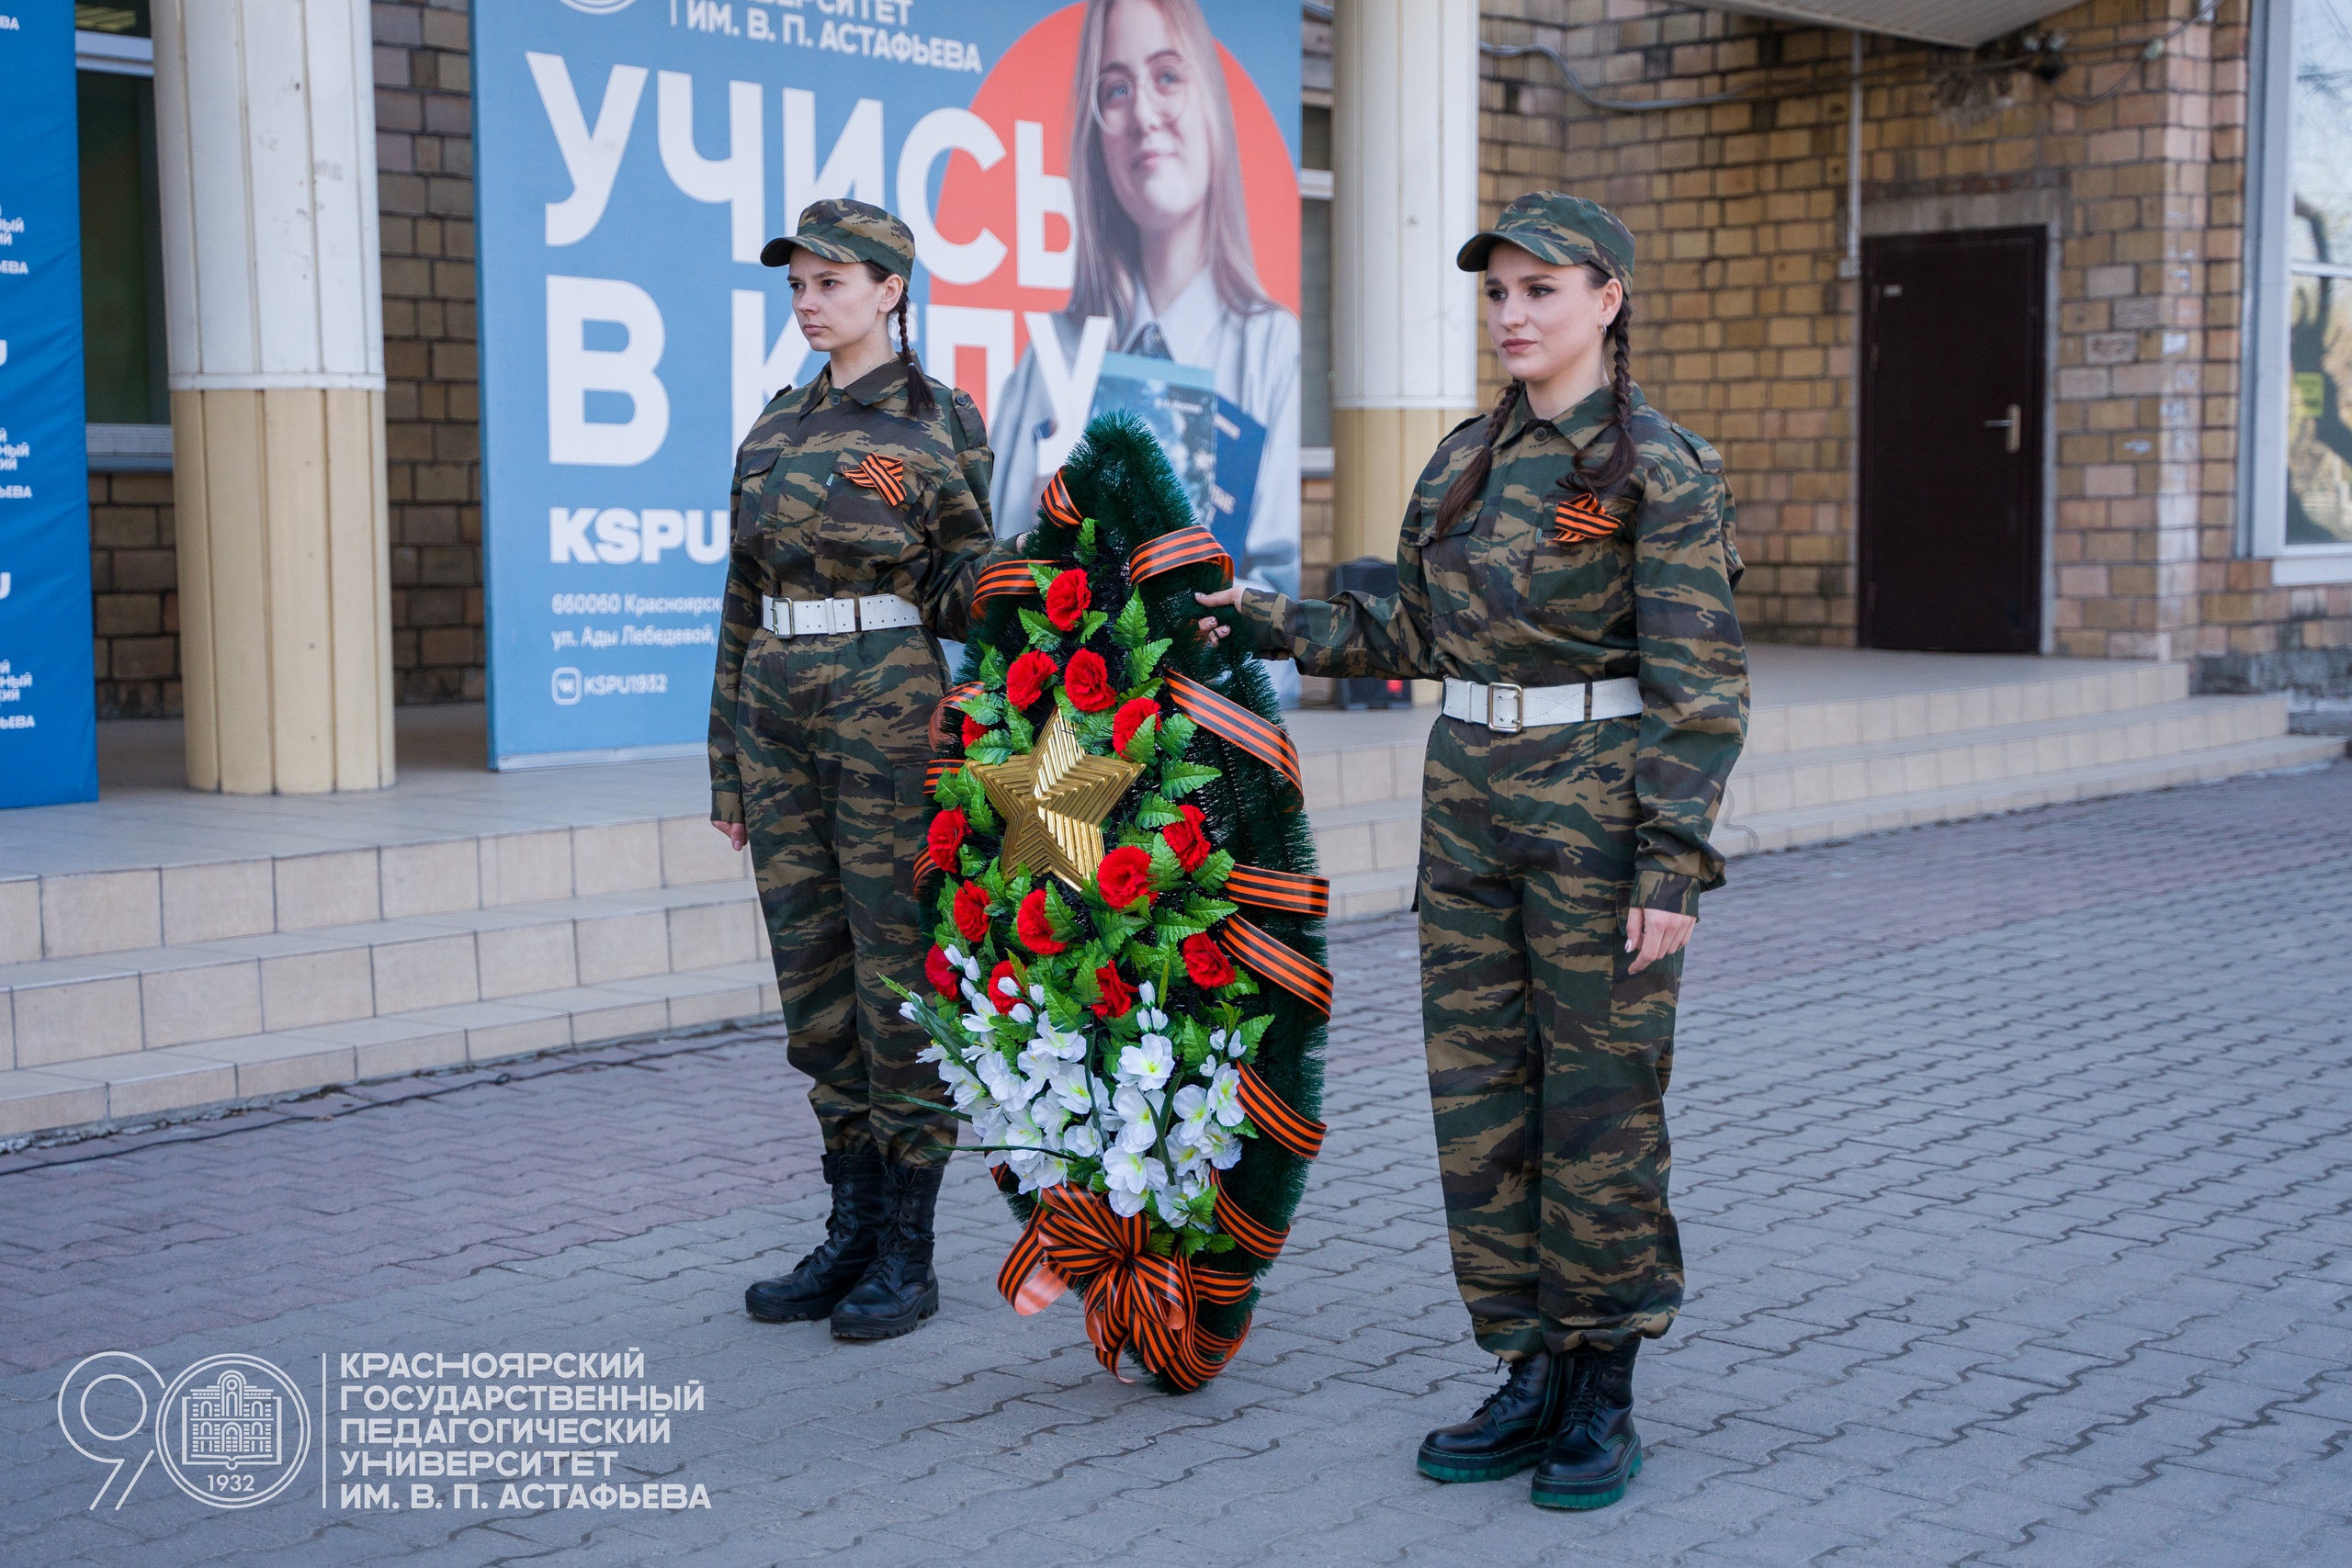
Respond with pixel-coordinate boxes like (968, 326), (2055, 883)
(89, 472), (179, 719)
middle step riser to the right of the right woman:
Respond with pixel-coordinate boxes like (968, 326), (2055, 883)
(1722, 696), (2286, 820)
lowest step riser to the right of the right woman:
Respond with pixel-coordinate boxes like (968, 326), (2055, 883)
(1714, 733), (2345, 856)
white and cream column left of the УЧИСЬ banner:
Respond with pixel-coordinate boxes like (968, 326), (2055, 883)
(155, 0), (393, 795)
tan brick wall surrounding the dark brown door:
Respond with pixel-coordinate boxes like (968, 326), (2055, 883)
(1479, 0), (2352, 686)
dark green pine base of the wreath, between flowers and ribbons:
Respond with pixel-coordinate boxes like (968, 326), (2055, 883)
(950, 413), (1324, 1392)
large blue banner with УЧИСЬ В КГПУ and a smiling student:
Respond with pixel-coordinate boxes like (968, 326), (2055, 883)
(473, 0), (1298, 766)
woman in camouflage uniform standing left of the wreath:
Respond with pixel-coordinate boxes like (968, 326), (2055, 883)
(710, 200), (1015, 1340)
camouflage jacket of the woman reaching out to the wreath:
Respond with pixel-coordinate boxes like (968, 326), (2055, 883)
(1239, 388), (1747, 912)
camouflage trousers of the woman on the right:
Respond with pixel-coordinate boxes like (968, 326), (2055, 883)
(1420, 719), (1681, 1359)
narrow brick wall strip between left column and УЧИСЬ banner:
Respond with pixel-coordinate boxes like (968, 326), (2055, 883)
(374, 0), (484, 703)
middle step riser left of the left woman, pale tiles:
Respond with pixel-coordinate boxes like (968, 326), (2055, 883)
(0, 879), (767, 1067)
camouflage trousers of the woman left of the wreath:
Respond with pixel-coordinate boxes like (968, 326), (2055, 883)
(736, 627), (955, 1164)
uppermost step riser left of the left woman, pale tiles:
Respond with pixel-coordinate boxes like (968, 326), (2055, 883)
(0, 816), (751, 964)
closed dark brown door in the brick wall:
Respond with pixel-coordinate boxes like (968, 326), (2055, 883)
(1860, 228), (2049, 653)
